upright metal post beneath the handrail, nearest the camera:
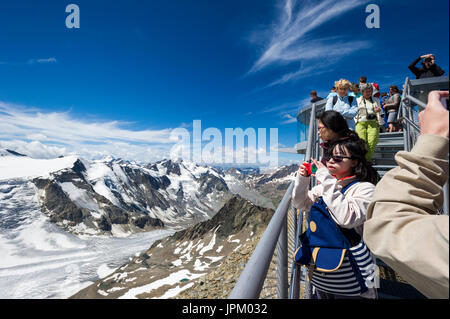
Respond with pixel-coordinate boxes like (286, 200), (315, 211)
(277, 214), (288, 299)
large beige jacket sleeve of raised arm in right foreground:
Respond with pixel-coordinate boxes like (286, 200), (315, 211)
(364, 135), (449, 298)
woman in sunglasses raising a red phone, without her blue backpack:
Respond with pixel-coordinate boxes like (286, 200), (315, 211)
(292, 136), (376, 299)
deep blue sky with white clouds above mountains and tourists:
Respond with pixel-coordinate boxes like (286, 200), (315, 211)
(0, 0), (449, 168)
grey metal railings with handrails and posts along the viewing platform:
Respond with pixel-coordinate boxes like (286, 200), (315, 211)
(229, 77), (449, 299)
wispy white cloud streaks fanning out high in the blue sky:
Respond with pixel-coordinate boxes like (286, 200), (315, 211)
(248, 0), (372, 86)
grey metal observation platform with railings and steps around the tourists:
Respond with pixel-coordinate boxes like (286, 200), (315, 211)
(229, 76), (449, 299)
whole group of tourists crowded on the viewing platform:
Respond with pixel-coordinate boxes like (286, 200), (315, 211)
(292, 55), (449, 299)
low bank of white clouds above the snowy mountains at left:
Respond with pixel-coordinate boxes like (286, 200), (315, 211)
(0, 102), (176, 161)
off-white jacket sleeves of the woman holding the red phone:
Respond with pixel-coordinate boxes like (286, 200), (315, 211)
(292, 168), (375, 234)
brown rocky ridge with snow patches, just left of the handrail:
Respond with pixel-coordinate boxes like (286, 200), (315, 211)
(72, 196), (274, 299)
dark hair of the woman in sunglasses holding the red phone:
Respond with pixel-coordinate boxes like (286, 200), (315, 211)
(326, 136), (378, 185)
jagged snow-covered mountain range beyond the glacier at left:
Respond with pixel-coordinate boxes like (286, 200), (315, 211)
(0, 151), (232, 236)
